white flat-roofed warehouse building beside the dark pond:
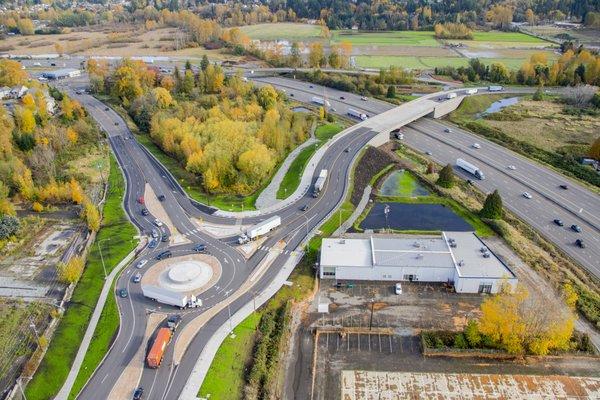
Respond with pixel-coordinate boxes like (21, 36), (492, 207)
(320, 232), (517, 293)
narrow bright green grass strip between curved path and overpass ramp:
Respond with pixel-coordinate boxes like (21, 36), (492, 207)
(276, 123), (344, 199)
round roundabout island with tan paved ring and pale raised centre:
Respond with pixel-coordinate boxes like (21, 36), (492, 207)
(141, 254), (221, 296)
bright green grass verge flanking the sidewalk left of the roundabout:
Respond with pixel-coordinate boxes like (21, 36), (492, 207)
(25, 155), (137, 400)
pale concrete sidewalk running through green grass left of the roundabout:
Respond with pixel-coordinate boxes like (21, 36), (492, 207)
(54, 247), (137, 400)
